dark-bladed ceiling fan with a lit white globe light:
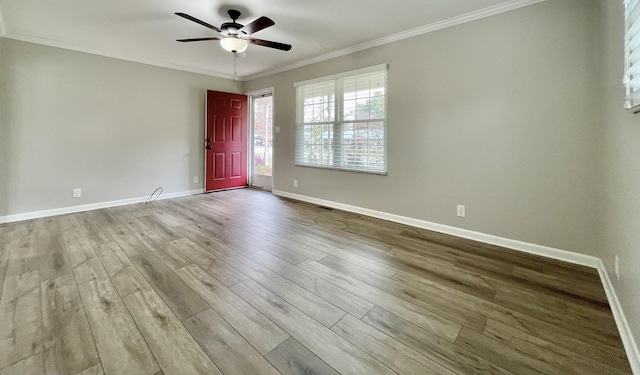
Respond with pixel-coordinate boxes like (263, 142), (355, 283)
(176, 9), (291, 54)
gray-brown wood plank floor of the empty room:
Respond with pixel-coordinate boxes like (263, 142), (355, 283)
(0, 189), (631, 375)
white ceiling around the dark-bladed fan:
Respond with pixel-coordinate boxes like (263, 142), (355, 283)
(0, 0), (543, 80)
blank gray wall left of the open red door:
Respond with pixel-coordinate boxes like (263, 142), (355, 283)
(0, 39), (242, 216)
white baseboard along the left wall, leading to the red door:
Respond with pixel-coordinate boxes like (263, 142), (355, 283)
(0, 189), (204, 224)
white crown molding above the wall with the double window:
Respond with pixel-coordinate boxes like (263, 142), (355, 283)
(239, 0), (546, 81)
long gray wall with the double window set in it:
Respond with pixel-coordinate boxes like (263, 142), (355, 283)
(245, 0), (601, 255)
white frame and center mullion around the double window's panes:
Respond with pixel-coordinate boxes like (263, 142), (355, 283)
(294, 64), (388, 175)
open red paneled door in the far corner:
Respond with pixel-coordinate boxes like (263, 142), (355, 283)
(205, 91), (248, 191)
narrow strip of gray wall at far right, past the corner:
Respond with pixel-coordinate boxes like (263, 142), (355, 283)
(597, 0), (640, 358)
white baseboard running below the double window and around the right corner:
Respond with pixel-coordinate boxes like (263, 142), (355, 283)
(273, 190), (640, 375)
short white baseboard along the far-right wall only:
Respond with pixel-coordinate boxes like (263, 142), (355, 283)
(597, 259), (640, 375)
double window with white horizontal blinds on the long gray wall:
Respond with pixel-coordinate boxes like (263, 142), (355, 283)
(295, 64), (387, 174)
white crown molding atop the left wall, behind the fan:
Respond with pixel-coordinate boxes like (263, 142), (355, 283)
(0, 33), (238, 80)
